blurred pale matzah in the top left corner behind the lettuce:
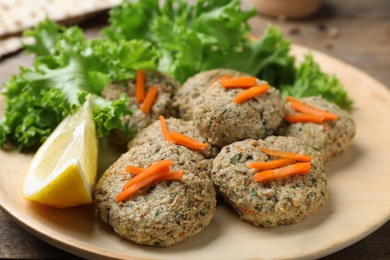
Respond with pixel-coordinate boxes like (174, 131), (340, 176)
(0, 0), (121, 57)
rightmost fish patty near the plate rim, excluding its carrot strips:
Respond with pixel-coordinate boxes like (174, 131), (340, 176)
(278, 96), (356, 161)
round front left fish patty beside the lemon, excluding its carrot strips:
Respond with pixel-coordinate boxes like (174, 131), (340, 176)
(95, 141), (216, 247)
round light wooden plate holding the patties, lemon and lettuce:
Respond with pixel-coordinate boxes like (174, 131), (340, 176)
(0, 45), (390, 259)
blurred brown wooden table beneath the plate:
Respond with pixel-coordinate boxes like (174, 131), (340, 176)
(0, 0), (390, 259)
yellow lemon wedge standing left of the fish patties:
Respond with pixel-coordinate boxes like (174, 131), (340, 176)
(22, 95), (98, 208)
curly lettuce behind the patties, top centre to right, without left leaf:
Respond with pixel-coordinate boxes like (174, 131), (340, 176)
(103, 0), (352, 109)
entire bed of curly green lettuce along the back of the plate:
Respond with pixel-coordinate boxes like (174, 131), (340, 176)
(0, 0), (351, 150)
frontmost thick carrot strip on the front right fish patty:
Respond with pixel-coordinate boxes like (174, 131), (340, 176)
(253, 162), (311, 182)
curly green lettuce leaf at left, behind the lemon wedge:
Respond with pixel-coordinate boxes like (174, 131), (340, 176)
(0, 20), (159, 150)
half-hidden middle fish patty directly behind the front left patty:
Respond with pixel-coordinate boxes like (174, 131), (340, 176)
(127, 117), (219, 158)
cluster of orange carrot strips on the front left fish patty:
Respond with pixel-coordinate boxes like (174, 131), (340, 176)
(116, 160), (184, 202)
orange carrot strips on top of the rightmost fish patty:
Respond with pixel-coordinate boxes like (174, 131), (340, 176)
(285, 96), (339, 123)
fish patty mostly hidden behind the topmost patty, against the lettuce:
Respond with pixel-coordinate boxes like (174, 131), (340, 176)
(174, 68), (248, 120)
